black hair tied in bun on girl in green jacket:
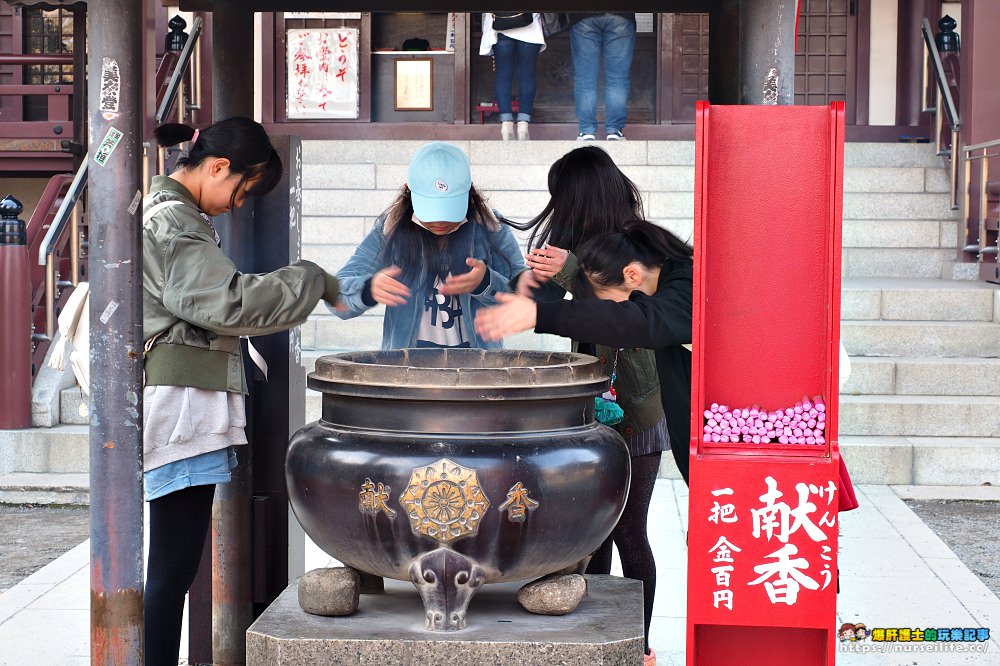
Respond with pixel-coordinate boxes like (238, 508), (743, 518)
(153, 116), (281, 205)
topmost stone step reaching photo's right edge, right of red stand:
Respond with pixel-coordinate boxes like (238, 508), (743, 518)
(840, 277), (1000, 322)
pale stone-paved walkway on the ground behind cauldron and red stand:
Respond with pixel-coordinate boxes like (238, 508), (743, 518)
(0, 479), (1000, 666)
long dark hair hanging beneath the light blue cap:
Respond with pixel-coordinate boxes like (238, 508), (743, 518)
(380, 185), (500, 285)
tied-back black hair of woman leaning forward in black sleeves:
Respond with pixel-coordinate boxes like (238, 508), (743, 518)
(574, 219), (693, 294)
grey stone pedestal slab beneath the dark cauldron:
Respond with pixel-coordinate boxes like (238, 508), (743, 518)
(247, 576), (643, 666)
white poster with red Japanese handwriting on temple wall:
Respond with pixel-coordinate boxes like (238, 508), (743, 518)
(286, 28), (360, 119)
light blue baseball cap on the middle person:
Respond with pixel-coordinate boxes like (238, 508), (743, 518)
(406, 141), (472, 222)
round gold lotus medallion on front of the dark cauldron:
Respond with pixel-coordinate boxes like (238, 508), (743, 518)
(399, 458), (490, 543)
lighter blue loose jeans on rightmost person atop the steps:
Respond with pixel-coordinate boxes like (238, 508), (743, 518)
(572, 14), (635, 134)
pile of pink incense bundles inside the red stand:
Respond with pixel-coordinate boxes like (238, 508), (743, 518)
(704, 395), (826, 444)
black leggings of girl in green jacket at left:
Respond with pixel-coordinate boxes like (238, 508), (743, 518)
(143, 485), (215, 666)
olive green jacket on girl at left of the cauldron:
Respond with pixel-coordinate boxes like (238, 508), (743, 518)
(142, 176), (339, 392)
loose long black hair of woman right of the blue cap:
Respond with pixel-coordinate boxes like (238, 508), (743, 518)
(512, 146), (645, 252)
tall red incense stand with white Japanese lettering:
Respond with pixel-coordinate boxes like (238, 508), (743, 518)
(687, 102), (844, 666)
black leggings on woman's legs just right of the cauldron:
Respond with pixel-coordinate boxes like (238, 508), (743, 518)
(587, 452), (660, 652)
